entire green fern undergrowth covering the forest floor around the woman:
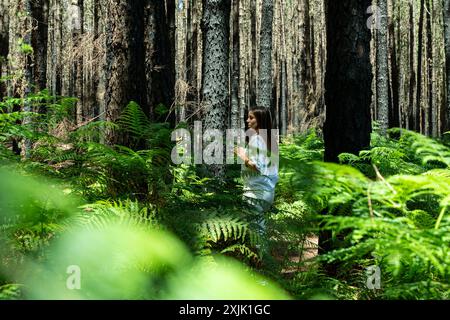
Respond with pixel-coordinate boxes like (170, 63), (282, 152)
(0, 90), (450, 299)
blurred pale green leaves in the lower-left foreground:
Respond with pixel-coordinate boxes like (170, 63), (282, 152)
(0, 168), (289, 299)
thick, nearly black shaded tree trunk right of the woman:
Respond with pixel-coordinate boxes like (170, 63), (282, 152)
(324, 0), (372, 162)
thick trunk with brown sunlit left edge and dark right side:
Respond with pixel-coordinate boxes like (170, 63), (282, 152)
(105, 0), (147, 144)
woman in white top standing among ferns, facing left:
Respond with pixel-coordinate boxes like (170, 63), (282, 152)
(236, 108), (278, 233)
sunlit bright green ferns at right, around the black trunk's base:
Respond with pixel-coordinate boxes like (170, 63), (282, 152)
(282, 130), (450, 299)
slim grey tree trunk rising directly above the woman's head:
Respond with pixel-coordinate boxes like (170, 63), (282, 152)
(256, 0), (273, 109)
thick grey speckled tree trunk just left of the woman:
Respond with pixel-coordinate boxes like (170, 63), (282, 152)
(202, 0), (231, 177)
